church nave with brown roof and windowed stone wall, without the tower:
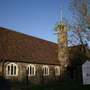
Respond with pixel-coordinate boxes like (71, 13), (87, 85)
(0, 28), (60, 84)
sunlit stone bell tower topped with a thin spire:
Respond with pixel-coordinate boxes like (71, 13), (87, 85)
(56, 9), (69, 74)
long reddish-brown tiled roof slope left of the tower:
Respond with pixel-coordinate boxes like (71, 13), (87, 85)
(0, 28), (59, 64)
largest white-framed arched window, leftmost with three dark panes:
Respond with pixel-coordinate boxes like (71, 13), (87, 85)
(6, 63), (18, 76)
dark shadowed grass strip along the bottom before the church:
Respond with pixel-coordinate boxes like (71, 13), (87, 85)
(0, 78), (90, 90)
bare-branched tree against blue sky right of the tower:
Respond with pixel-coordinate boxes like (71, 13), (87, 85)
(69, 0), (90, 44)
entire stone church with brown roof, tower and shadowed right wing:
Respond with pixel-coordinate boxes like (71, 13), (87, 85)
(0, 22), (90, 84)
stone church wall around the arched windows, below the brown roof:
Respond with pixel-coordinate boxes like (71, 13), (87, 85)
(4, 62), (60, 84)
